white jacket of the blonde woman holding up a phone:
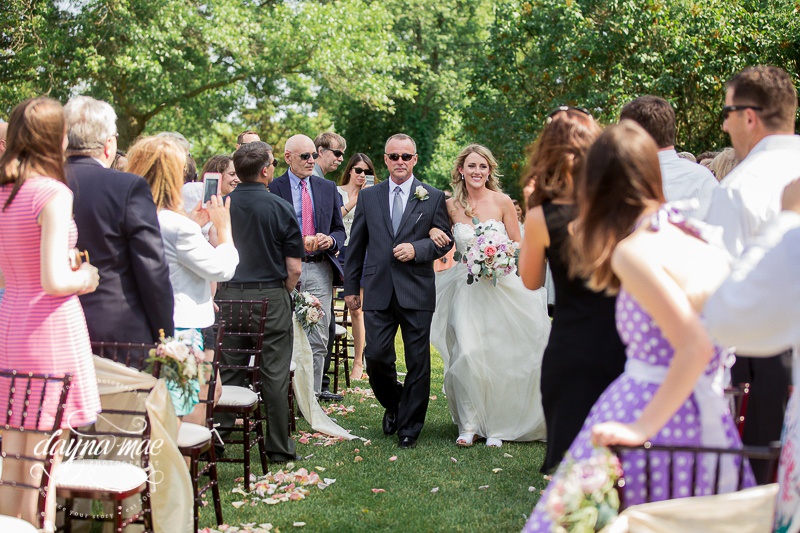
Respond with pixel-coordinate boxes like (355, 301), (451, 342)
(158, 209), (239, 328)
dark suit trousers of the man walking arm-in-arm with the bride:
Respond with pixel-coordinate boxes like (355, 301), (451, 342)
(364, 294), (433, 439)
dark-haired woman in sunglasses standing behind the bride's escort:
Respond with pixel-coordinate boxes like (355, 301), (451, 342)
(336, 153), (375, 380)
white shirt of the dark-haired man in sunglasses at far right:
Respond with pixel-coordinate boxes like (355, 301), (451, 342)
(706, 135), (800, 257)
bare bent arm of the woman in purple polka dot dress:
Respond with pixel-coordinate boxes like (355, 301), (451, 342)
(592, 235), (714, 446)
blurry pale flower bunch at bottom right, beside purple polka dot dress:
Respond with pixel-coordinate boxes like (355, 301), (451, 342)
(545, 448), (622, 533)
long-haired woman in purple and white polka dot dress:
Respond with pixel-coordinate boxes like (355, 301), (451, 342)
(525, 121), (754, 532)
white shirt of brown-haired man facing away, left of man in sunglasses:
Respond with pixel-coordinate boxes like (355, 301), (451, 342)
(658, 149), (719, 220)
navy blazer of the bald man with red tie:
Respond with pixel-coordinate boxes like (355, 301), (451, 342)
(269, 172), (347, 285)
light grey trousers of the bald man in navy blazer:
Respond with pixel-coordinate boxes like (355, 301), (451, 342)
(300, 261), (333, 396)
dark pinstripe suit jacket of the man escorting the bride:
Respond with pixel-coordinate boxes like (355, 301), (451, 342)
(344, 178), (453, 311)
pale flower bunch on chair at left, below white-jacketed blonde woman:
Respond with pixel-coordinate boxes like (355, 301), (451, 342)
(147, 329), (212, 398)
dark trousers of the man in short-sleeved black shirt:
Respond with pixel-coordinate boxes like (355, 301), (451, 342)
(215, 287), (295, 461)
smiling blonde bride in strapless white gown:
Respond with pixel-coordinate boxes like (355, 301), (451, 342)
(431, 144), (550, 447)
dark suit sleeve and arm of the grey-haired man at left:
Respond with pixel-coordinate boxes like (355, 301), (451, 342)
(125, 178), (175, 341)
